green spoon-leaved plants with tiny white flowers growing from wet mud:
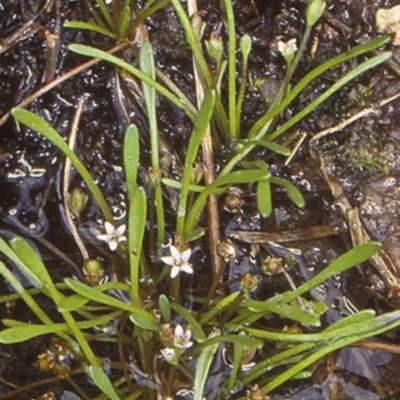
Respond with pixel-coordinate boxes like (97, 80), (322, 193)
(0, 0), (400, 400)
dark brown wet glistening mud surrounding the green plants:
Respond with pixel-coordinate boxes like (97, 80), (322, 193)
(0, 0), (400, 400)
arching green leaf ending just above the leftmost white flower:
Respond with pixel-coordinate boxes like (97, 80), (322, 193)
(11, 108), (113, 221)
